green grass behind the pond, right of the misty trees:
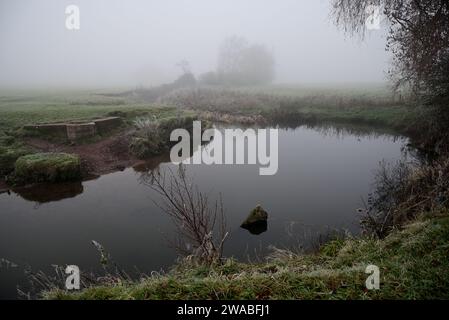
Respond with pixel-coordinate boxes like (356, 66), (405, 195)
(250, 84), (423, 131)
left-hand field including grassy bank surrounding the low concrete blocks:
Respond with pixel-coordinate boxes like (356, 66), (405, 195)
(0, 91), (192, 185)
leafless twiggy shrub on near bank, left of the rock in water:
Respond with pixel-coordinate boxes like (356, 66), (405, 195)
(144, 164), (229, 264)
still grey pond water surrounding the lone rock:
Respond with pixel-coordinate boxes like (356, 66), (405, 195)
(0, 126), (407, 298)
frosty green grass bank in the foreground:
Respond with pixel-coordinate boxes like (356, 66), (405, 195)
(43, 213), (449, 299)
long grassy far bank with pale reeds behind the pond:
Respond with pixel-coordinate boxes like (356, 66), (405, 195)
(161, 86), (422, 133)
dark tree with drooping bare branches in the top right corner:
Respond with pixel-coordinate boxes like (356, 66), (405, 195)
(332, 0), (449, 105)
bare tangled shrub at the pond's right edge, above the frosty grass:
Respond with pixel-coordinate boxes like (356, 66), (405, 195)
(361, 159), (449, 238)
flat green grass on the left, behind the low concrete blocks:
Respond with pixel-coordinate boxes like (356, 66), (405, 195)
(0, 91), (191, 175)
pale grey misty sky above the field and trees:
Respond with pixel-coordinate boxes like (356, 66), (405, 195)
(0, 0), (389, 88)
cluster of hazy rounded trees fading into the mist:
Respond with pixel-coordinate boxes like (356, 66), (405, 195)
(199, 36), (275, 86)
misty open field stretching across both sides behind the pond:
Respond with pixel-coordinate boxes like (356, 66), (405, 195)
(0, 85), (416, 133)
